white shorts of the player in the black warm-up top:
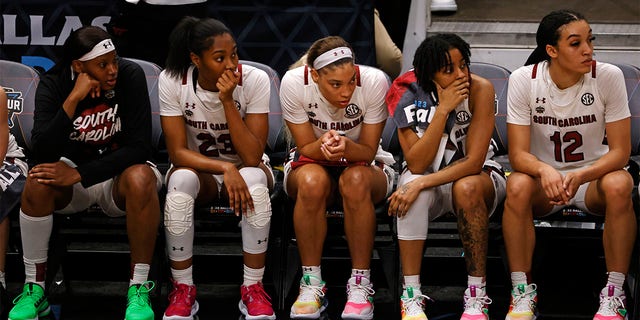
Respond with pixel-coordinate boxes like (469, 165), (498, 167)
(56, 158), (162, 217)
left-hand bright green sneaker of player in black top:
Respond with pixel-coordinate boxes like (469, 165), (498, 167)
(9, 282), (51, 320)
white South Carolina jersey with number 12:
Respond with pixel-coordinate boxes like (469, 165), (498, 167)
(508, 61), (630, 170)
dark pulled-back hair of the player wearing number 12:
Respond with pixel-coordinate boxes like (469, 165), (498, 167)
(524, 9), (586, 66)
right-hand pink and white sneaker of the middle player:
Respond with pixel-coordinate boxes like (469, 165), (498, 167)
(342, 276), (376, 320)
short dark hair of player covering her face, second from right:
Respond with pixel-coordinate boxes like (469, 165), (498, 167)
(413, 33), (471, 92)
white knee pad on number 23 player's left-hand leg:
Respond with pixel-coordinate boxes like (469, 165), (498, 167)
(164, 191), (194, 235)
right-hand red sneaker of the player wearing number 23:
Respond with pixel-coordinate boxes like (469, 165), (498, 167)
(238, 282), (276, 320)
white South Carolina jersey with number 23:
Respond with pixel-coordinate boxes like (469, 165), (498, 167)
(159, 65), (270, 165)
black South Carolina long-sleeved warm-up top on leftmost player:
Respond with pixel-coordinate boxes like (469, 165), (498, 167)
(31, 59), (151, 187)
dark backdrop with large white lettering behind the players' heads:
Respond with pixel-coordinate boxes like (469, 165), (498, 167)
(0, 0), (375, 75)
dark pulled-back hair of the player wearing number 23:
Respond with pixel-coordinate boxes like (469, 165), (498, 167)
(165, 17), (233, 77)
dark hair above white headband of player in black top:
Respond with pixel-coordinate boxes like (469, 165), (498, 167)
(51, 26), (111, 72)
